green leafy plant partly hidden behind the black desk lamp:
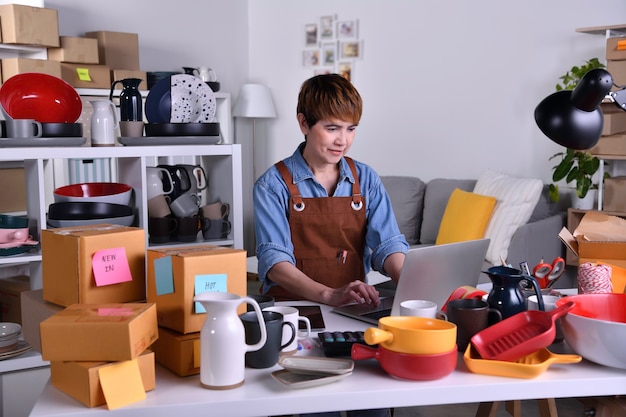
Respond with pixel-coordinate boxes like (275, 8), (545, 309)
(548, 58), (608, 202)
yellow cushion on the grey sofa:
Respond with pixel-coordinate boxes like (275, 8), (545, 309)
(435, 188), (496, 245)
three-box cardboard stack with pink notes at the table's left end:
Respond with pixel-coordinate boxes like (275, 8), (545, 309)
(33, 224), (158, 408)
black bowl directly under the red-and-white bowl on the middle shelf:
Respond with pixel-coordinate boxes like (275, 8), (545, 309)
(48, 201), (133, 220)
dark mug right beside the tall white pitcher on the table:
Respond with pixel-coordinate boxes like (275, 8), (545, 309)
(239, 311), (297, 368)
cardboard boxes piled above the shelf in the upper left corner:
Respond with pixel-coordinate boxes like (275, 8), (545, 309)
(0, 4), (147, 89)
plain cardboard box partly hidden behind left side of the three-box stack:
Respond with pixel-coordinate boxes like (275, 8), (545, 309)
(21, 289), (63, 352)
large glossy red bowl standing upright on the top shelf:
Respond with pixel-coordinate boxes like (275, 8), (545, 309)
(0, 72), (83, 123)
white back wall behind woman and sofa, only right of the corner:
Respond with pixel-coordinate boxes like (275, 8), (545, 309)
(249, 0), (626, 181)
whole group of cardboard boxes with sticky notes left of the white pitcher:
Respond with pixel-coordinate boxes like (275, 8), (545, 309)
(22, 224), (247, 408)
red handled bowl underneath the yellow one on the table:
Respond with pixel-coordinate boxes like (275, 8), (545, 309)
(352, 343), (458, 381)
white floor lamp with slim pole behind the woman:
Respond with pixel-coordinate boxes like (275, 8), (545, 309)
(233, 84), (276, 182)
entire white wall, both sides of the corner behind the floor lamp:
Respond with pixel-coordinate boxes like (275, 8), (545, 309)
(45, 0), (626, 249)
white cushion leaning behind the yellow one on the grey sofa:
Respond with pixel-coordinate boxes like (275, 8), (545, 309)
(474, 170), (543, 265)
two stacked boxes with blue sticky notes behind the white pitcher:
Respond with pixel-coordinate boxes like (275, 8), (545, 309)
(147, 245), (247, 376)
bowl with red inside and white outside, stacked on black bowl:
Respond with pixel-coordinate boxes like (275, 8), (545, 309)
(54, 182), (133, 205)
